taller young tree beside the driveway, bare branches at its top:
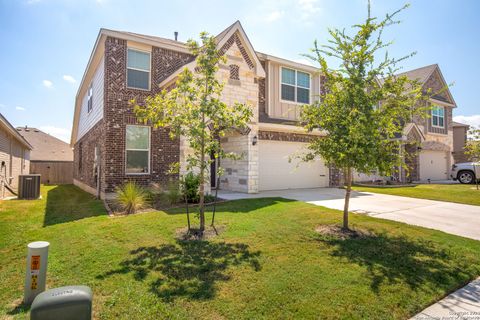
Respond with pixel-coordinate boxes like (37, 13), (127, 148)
(301, 3), (426, 229)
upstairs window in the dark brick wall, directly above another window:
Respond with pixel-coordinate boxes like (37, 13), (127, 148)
(127, 49), (150, 90)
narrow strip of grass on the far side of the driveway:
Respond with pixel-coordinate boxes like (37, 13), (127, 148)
(353, 184), (480, 206)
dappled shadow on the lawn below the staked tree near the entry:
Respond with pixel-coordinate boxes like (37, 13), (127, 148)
(96, 240), (261, 301)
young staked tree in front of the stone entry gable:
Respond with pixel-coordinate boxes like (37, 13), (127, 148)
(135, 32), (252, 236)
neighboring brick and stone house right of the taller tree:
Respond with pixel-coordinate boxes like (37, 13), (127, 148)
(354, 64), (456, 182)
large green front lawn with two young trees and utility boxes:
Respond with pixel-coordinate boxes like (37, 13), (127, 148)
(0, 186), (480, 319)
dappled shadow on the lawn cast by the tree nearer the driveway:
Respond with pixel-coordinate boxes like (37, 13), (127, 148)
(319, 234), (480, 294)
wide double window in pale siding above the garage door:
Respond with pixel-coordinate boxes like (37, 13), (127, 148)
(281, 68), (310, 103)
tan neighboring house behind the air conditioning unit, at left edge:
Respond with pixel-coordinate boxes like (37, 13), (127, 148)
(0, 113), (32, 199)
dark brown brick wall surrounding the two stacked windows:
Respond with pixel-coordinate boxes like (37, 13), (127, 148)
(74, 37), (188, 194)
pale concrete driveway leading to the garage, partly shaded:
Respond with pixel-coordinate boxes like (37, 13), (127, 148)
(219, 188), (480, 240)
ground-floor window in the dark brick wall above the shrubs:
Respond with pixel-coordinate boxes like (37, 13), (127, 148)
(125, 126), (150, 174)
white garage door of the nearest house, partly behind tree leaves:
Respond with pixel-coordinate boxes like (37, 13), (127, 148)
(258, 140), (328, 190)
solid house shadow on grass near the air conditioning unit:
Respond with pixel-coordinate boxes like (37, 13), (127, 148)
(43, 185), (107, 227)
